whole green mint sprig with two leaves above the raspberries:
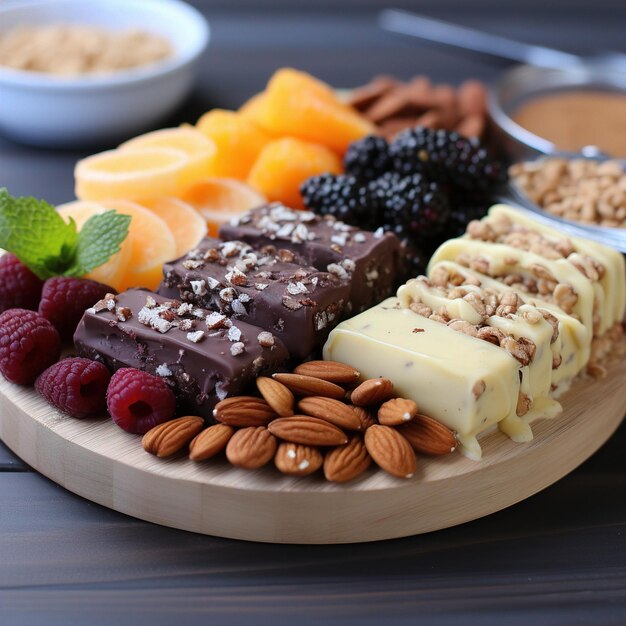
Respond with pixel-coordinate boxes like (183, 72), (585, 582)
(0, 188), (131, 280)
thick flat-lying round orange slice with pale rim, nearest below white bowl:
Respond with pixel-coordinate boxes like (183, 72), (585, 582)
(74, 148), (189, 200)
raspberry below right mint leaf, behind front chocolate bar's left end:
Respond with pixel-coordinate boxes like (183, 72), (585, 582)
(39, 276), (117, 340)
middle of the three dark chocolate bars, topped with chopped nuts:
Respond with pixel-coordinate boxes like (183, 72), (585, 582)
(159, 238), (350, 359)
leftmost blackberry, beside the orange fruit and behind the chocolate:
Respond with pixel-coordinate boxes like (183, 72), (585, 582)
(300, 174), (377, 229)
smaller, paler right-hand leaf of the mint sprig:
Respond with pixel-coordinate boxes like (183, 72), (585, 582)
(63, 211), (130, 276)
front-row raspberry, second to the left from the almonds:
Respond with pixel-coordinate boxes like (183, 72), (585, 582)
(35, 357), (111, 418)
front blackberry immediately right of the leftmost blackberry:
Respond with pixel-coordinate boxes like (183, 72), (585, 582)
(369, 172), (450, 248)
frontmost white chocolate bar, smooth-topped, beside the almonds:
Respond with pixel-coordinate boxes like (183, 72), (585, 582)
(324, 298), (520, 459)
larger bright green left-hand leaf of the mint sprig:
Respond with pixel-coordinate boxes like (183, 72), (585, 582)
(0, 188), (78, 280)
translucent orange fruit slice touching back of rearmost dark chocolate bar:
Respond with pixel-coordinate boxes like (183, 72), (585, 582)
(181, 178), (267, 237)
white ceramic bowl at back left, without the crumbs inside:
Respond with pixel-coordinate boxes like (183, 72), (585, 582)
(0, 0), (209, 147)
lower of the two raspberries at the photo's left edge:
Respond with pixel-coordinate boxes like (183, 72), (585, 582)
(0, 309), (61, 385)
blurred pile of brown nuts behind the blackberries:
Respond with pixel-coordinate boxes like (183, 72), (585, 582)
(348, 76), (487, 140)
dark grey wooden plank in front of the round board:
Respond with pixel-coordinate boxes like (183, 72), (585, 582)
(0, 471), (626, 624)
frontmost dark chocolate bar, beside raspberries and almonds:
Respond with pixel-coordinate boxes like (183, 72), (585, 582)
(74, 289), (289, 418)
